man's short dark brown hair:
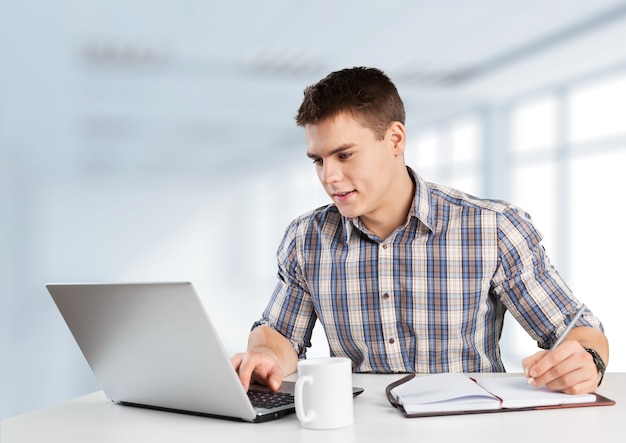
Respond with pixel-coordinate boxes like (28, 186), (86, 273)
(296, 67), (405, 139)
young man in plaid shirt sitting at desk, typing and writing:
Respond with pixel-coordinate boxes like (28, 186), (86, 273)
(232, 68), (608, 393)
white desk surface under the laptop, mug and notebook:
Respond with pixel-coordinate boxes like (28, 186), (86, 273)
(2, 373), (626, 443)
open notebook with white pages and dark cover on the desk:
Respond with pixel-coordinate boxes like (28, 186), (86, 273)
(387, 373), (615, 417)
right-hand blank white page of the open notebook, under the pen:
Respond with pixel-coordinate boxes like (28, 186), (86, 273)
(478, 376), (596, 408)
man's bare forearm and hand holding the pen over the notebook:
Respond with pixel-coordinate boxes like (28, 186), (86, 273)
(522, 326), (609, 394)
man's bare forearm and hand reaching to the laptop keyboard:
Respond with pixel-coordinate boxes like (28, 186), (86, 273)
(230, 326), (298, 391)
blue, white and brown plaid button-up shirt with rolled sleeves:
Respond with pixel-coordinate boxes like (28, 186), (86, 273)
(255, 169), (602, 373)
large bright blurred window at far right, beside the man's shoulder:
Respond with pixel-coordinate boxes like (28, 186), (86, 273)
(500, 74), (626, 370)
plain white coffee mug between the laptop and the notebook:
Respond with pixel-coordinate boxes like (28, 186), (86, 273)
(294, 357), (354, 429)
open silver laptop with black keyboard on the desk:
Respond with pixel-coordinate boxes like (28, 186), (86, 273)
(46, 283), (359, 422)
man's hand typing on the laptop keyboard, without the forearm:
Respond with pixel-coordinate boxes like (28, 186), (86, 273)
(230, 351), (283, 392)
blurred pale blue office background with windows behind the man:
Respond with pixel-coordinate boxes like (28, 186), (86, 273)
(0, 0), (626, 424)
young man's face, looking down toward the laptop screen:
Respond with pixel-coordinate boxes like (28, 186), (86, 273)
(305, 113), (404, 225)
